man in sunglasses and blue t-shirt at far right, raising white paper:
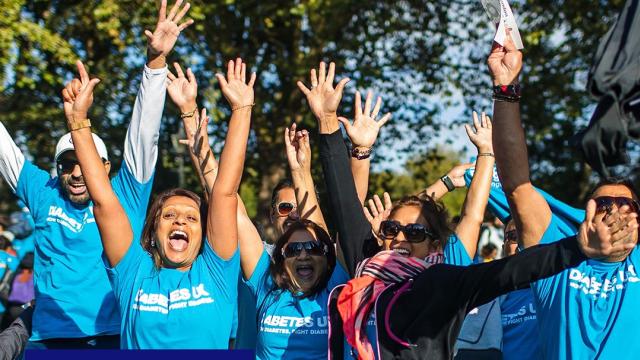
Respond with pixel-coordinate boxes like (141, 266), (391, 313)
(487, 33), (640, 359)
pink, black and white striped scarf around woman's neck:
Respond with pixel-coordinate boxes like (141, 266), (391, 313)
(338, 251), (432, 359)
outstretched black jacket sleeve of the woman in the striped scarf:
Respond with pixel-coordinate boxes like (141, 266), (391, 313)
(459, 236), (587, 311)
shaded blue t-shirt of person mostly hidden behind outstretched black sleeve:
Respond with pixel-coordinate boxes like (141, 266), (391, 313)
(499, 289), (536, 360)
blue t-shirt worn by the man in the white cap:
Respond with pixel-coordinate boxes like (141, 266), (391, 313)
(16, 161), (153, 341)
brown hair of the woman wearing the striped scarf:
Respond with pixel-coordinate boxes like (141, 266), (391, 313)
(389, 192), (452, 249)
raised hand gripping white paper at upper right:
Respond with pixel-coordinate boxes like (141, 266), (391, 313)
(487, 29), (522, 85)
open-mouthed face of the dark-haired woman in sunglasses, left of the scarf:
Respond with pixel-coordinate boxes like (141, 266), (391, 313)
(284, 228), (327, 292)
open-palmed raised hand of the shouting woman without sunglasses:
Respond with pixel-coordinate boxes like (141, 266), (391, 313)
(216, 58), (256, 111)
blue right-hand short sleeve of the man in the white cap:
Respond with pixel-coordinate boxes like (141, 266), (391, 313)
(111, 163), (153, 239)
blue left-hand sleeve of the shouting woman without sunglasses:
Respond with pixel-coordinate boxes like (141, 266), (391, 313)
(102, 240), (145, 301)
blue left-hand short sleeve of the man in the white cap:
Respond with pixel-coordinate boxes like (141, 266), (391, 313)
(16, 160), (52, 219)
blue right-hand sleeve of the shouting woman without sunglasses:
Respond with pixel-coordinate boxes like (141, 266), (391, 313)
(202, 242), (240, 303)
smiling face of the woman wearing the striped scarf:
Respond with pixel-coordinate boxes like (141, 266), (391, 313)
(383, 205), (441, 259)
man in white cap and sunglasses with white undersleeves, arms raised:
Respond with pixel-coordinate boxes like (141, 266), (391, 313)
(0, 0), (193, 349)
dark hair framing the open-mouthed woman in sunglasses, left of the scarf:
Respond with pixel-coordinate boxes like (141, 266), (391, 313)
(270, 219), (336, 299)
